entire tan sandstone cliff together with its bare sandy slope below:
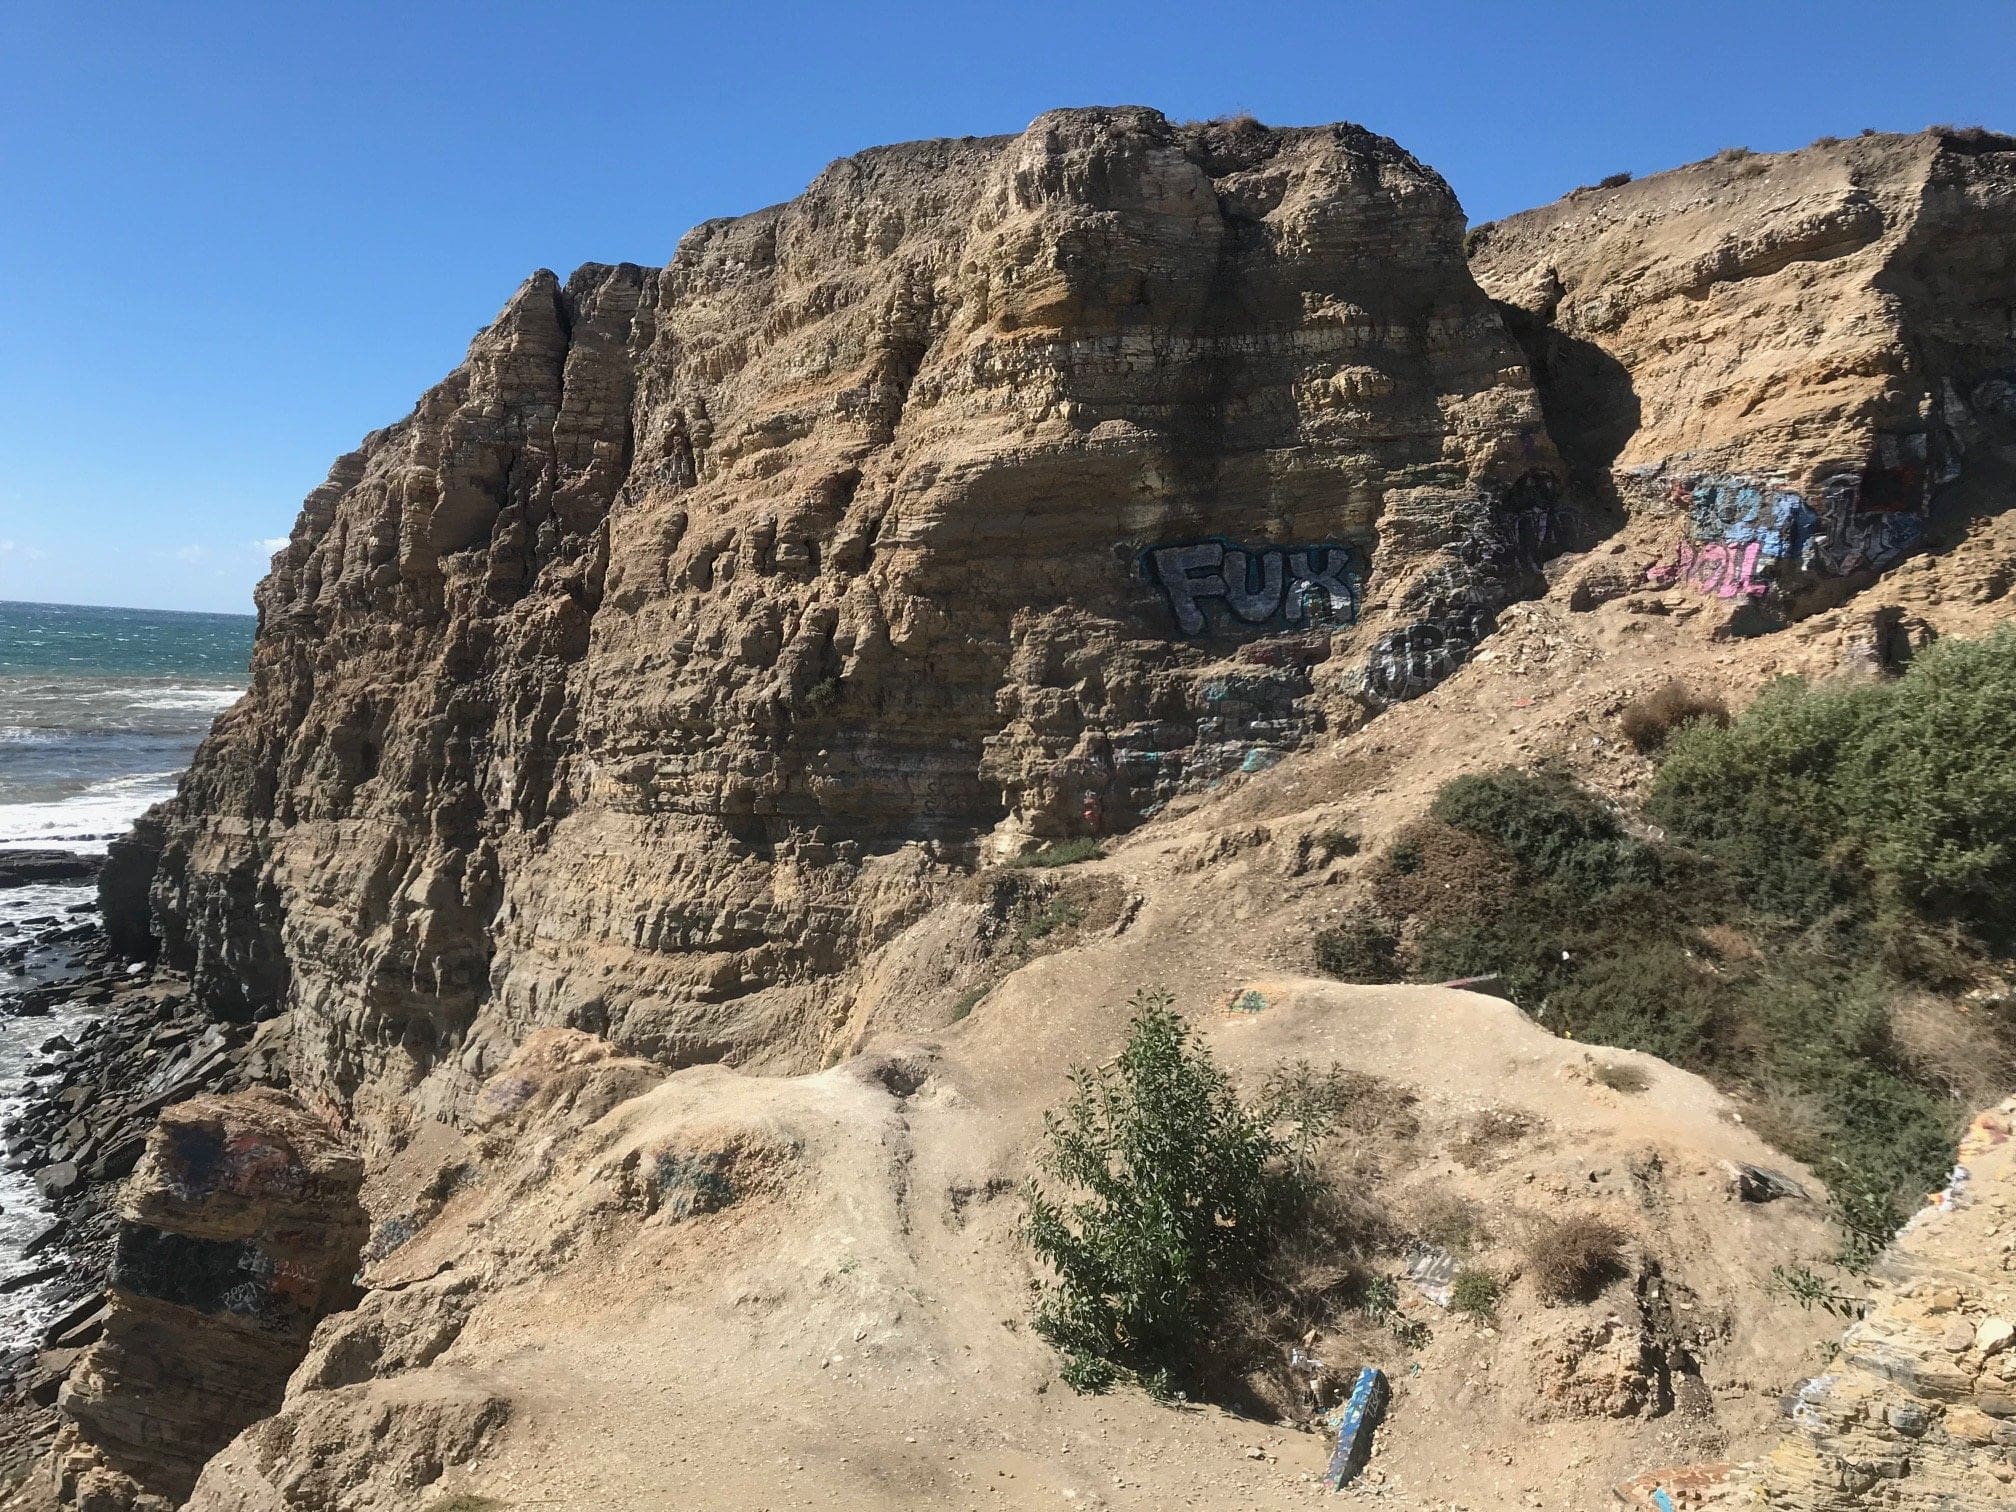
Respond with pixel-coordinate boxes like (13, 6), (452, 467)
(43, 111), (2016, 1512)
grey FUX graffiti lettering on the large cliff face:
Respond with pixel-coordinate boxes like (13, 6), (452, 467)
(1141, 540), (1365, 635)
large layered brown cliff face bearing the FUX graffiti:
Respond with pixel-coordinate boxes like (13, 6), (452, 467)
(134, 109), (1558, 1123)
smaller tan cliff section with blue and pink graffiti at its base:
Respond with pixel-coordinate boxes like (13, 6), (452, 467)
(1474, 131), (2016, 629)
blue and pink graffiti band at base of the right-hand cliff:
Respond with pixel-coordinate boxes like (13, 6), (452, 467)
(1645, 433), (1954, 599)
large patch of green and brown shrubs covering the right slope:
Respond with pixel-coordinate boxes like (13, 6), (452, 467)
(1316, 633), (2016, 1254)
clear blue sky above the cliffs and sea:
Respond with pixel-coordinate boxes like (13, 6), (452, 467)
(0, 0), (2016, 611)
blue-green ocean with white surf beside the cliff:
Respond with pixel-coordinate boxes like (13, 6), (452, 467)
(0, 603), (254, 1343)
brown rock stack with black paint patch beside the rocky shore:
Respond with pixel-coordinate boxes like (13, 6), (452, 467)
(54, 1089), (367, 1512)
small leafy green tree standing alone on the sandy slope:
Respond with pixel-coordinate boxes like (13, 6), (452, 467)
(1026, 992), (1296, 1393)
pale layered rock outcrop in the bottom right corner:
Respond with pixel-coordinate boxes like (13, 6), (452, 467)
(1756, 1099), (2016, 1512)
